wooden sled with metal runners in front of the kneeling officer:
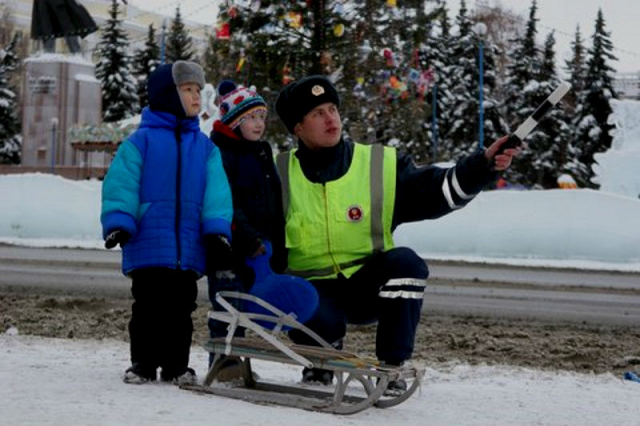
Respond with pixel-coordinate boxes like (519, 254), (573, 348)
(182, 291), (423, 414)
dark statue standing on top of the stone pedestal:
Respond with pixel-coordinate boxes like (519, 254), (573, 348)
(31, 0), (98, 53)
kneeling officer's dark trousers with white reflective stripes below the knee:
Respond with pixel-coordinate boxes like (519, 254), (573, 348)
(289, 247), (429, 365)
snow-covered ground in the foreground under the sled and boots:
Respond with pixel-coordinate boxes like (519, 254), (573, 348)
(0, 334), (640, 426)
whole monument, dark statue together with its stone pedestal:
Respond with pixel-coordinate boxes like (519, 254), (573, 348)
(22, 0), (102, 173)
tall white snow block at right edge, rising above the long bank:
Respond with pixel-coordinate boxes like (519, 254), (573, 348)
(593, 99), (640, 199)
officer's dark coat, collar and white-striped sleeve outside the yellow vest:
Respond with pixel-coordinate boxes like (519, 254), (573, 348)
(295, 140), (497, 229)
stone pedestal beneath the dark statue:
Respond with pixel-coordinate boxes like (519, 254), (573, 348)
(22, 54), (102, 172)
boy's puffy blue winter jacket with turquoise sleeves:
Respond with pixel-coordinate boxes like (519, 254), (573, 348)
(100, 108), (233, 275)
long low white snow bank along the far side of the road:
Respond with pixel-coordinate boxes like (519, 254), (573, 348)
(0, 174), (640, 270)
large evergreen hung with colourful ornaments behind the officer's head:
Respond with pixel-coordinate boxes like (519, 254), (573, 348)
(205, 0), (444, 151)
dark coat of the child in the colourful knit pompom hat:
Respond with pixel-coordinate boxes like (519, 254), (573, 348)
(211, 121), (287, 273)
